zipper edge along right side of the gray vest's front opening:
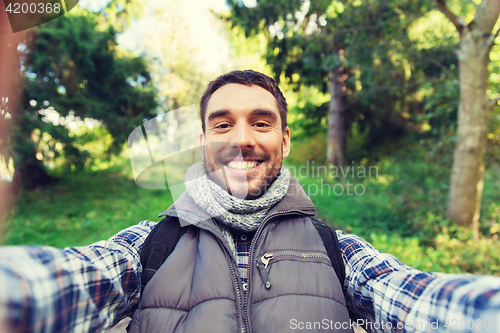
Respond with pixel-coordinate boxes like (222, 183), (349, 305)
(242, 210), (314, 333)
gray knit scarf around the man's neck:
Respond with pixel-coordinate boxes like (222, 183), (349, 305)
(184, 162), (290, 252)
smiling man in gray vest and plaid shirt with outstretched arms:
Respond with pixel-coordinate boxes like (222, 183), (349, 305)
(0, 71), (500, 333)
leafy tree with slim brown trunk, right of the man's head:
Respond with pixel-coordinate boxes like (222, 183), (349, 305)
(230, 0), (427, 165)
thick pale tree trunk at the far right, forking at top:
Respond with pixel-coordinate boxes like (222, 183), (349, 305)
(437, 0), (500, 236)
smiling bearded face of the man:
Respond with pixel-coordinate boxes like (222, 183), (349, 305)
(200, 84), (290, 199)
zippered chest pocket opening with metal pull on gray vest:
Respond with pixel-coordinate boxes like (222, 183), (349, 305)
(257, 250), (332, 290)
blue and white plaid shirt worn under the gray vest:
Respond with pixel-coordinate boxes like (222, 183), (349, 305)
(0, 222), (500, 332)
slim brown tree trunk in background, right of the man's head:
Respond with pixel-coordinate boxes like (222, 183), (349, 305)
(326, 68), (346, 166)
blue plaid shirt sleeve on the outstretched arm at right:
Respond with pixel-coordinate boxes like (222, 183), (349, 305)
(337, 231), (500, 332)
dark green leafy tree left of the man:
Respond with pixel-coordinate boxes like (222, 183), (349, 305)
(6, 11), (156, 189)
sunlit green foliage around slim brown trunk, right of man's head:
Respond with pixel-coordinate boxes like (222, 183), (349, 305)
(229, 0), (457, 158)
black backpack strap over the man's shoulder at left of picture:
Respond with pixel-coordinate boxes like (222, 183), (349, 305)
(141, 216), (188, 291)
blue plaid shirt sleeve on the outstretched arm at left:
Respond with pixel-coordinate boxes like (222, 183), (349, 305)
(0, 221), (155, 332)
